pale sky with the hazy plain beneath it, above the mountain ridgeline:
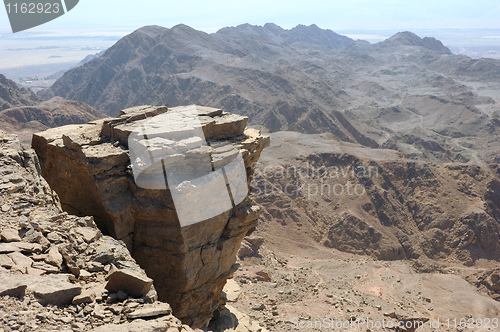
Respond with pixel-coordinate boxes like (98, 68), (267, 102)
(0, 0), (500, 79)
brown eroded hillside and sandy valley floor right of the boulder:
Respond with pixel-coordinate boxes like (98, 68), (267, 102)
(231, 132), (500, 331)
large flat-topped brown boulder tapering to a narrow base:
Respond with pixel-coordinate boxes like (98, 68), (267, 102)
(33, 106), (269, 327)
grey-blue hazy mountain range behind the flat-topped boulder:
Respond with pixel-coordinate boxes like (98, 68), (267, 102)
(40, 24), (500, 163)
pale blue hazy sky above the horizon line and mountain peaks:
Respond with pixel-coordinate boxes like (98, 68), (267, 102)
(0, 0), (500, 34)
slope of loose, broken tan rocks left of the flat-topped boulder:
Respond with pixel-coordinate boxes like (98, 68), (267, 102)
(0, 132), (198, 331)
